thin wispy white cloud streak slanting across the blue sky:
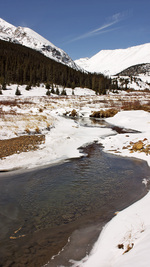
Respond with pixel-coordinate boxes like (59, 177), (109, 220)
(67, 13), (125, 43)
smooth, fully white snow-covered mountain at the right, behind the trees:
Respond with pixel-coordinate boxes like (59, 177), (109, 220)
(75, 43), (150, 75)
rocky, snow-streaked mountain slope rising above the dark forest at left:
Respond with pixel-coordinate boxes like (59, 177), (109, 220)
(0, 18), (81, 70)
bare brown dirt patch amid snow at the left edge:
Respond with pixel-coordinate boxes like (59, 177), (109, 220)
(0, 135), (45, 159)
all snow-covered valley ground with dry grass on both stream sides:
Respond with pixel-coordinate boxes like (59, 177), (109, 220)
(0, 85), (150, 267)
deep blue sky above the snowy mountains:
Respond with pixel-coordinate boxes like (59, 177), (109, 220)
(0, 0), (150, 60)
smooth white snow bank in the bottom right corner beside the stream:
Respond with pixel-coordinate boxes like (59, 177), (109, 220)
(74, 193), (150, 267)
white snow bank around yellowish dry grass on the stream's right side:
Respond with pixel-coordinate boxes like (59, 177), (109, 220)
(102, 110), (150, 165)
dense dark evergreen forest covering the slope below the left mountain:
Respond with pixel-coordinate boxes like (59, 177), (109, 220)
(0, 40), (111, 93)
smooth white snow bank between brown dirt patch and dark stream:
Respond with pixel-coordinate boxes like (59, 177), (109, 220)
(0, 114), (112, 171)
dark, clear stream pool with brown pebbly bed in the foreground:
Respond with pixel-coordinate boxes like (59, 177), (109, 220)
(0, 120), (150, 267)
